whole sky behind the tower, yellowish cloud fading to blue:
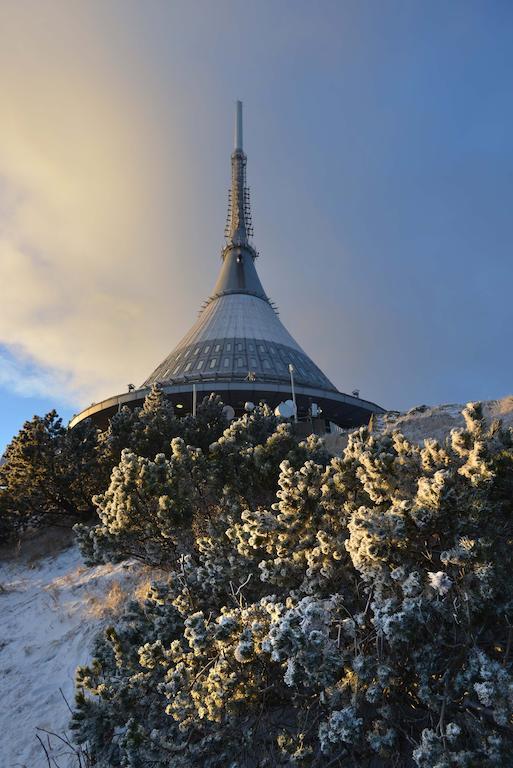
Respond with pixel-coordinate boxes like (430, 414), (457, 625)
(0, 0), (513, 446)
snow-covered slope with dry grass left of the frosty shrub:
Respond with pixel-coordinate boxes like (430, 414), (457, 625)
(0, 546), (141, 768)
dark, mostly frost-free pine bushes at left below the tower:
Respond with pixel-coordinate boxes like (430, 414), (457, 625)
(0, 385), (226, 551)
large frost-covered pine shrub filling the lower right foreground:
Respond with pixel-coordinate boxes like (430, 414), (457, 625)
(74, 405), (513, 768)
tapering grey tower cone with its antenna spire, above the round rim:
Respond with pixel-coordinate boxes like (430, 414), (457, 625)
(142, 102), (337, 392)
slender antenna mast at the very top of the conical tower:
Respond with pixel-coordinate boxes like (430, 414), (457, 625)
(225, 101), (253, 247)
